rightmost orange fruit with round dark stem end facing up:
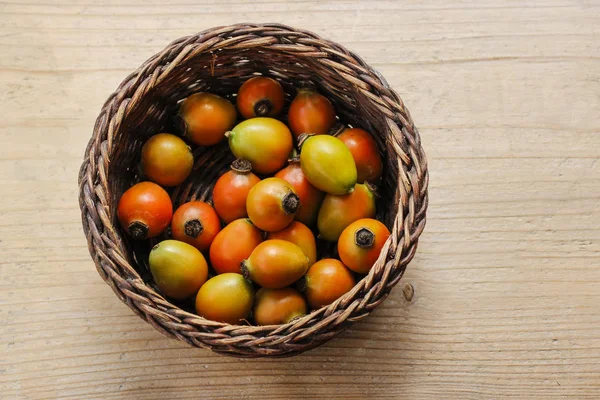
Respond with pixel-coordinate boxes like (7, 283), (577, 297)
(338, 218), (390, 274)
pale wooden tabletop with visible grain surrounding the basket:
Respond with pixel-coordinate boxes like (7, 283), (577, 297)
(0, 0), (600, 400)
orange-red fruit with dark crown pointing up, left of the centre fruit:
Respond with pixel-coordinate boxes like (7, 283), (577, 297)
(213, 159), (260, 224)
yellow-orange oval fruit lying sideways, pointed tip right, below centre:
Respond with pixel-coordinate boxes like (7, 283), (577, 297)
(242, 239), (310, 289)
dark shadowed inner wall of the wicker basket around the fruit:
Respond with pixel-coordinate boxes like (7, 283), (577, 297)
(108, 48), (398, 292)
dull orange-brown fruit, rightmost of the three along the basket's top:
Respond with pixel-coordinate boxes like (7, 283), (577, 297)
(288, 89), (336, 138)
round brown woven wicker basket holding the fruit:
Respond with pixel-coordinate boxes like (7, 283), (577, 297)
(79, 24), (428, 357)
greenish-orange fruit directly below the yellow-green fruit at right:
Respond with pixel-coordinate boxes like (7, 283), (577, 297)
(317, 183), (375, 242)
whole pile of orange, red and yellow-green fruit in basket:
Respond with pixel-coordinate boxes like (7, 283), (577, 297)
(117, 76), (390, 325)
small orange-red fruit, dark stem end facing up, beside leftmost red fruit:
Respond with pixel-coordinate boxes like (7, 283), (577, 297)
(171, 201), (221, 251)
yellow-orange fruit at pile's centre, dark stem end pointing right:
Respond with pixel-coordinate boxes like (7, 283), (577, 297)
(246, 178), (300, 232)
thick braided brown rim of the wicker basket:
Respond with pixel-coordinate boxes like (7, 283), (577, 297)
(79, 24), (428, 357)
